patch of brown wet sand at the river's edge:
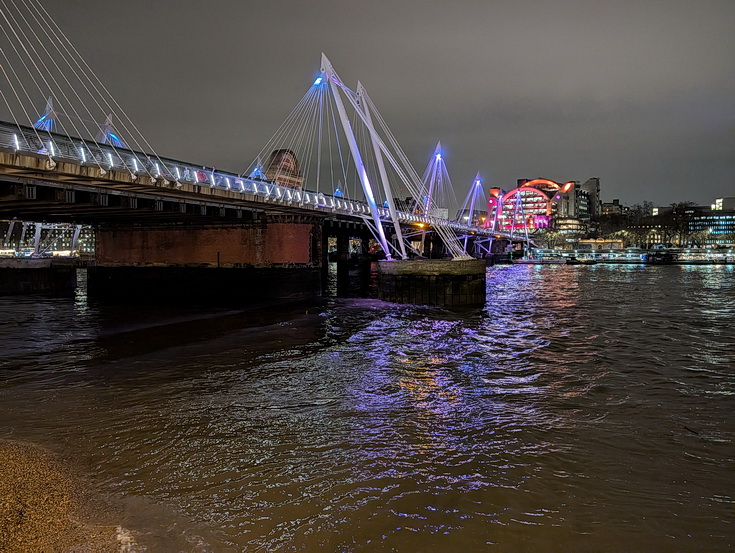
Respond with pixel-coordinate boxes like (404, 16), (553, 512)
(0, 441), (122, 553)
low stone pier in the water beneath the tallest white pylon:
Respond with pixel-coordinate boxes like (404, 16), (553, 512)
(378, 259), (486, 307)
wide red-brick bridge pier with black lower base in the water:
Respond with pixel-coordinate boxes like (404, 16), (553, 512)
(88, 216), (322, 306)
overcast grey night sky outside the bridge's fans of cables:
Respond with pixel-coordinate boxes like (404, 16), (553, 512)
(38, 0), (735, 205)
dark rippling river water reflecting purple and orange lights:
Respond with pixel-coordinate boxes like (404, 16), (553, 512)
(0, 264), (735, 553)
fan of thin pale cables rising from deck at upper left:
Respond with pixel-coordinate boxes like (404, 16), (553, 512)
(0, 0), (183, 182)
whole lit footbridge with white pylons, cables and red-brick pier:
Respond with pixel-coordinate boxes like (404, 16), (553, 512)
(0, 0), (510, 302)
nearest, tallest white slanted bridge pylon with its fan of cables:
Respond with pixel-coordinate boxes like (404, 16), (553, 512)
(250, 54), (466, 259)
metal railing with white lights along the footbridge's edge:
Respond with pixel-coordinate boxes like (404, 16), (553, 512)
(0, 121), (504, 235)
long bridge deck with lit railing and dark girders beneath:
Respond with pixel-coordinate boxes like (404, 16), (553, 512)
(0, 122), (506, 236)
